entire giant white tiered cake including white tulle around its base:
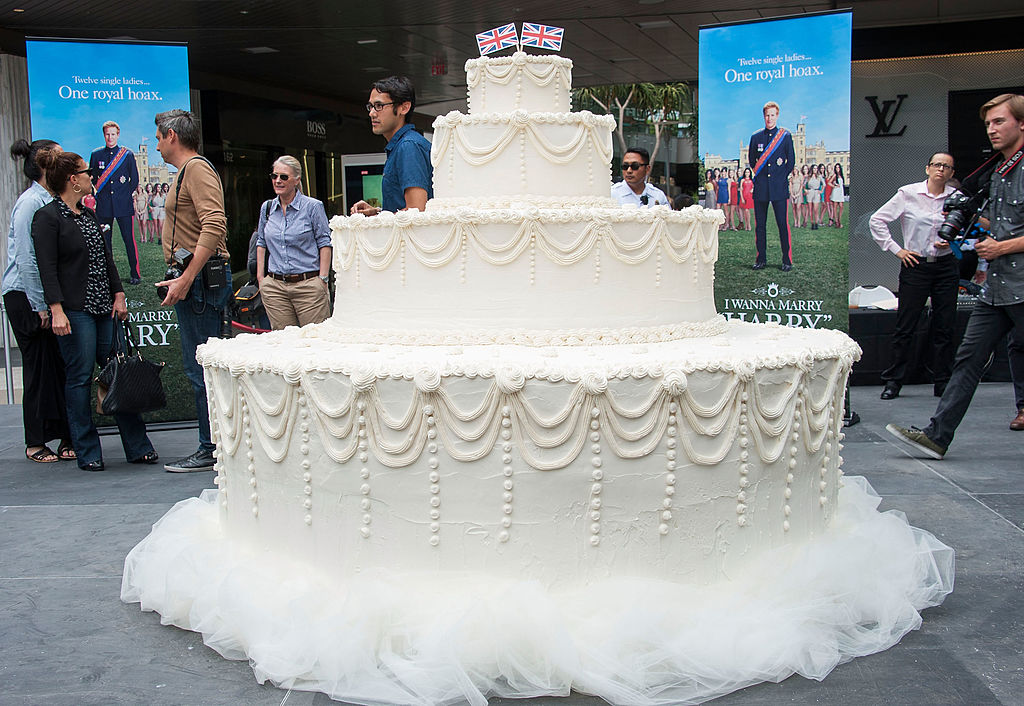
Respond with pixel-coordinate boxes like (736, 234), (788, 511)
(122, 52), (951, 704)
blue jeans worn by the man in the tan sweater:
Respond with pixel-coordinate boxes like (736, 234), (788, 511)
(174, 264), (231, 452)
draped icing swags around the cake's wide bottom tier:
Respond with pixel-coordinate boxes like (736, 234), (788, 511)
(214, 348), (851, 473)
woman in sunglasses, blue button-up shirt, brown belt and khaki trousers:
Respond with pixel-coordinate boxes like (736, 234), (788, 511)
(256, 155), (332, 329)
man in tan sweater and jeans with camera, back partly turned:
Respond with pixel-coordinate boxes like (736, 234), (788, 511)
(155, 110), (231, 472)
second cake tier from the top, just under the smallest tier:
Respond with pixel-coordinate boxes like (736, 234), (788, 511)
(430, 110), (615, 198)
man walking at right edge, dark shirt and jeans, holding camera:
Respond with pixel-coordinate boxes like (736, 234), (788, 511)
(886, 93), (1024, 459)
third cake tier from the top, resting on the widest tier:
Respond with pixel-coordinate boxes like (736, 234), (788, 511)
(331, 207), (724, 344)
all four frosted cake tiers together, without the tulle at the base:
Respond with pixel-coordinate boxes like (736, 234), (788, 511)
(198, 46), (859, 585)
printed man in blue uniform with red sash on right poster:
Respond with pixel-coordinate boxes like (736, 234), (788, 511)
(746, 100), (797, 273)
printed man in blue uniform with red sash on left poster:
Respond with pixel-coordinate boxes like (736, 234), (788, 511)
(89, 120), (142, 285)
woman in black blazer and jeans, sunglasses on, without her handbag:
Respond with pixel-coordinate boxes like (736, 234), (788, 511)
(32, 147), (158, 470)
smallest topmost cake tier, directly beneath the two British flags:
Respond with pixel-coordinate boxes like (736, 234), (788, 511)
(466, 51), (572, 113)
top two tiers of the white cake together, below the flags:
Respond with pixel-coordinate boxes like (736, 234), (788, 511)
(430, 51), (617, 204)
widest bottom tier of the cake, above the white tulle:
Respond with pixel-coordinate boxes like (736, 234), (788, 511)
(199, 323), (859, 584)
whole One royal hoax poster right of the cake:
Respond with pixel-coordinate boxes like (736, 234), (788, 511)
(698, 11), (857, 330)
